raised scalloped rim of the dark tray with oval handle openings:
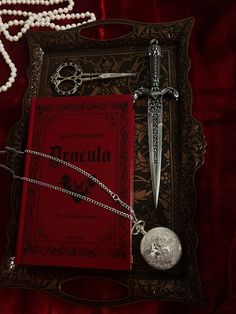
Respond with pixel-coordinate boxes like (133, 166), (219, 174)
(0, 18), (205, 306)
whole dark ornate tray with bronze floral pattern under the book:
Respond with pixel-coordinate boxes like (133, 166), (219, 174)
(0, 18), (205, 306)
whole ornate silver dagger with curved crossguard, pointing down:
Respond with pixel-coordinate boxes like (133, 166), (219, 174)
(134, 39), (179, 208)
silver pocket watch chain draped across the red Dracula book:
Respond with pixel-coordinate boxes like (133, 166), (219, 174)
(0, 146), (145, 234)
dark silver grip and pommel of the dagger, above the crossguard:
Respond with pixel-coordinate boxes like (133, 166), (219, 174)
(148, 39), (161, 90)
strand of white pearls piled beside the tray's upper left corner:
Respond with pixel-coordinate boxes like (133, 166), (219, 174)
(0, 0), (96, 93)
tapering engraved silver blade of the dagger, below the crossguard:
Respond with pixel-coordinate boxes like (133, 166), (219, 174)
(148, 98), (163, 208)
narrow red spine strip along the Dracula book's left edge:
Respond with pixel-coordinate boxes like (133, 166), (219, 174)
(16, 98), (37, 264)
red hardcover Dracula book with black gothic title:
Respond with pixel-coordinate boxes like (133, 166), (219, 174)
(16, 95), (134, 270)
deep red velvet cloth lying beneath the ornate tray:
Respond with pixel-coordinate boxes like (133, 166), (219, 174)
(0, 0), (236, 314)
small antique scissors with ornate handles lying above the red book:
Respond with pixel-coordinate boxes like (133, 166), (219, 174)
(51, 62), (136, 95)
